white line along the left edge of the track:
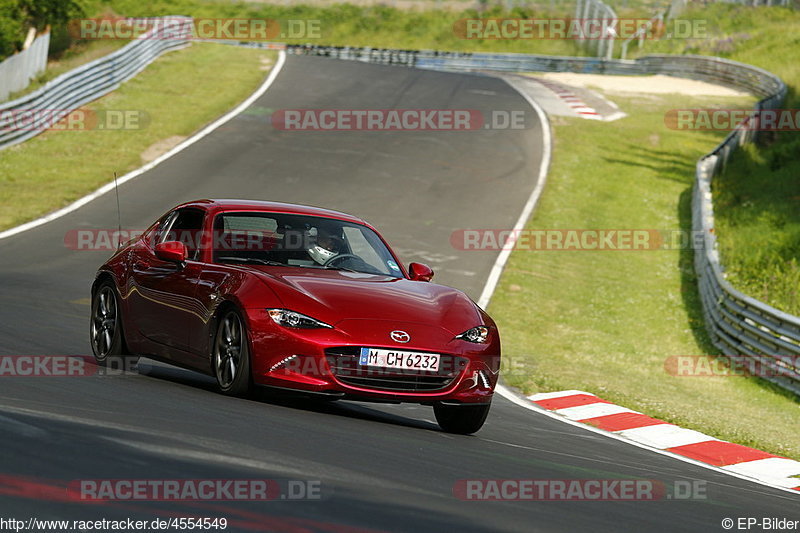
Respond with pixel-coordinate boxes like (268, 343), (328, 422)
(0, 50), (286, 239)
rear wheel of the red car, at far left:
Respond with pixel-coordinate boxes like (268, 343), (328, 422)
(89, 281), (139, 370)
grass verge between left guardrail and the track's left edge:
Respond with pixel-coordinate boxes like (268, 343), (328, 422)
(0, 44), (275, 229)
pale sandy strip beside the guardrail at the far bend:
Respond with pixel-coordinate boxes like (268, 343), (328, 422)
(536, 72), (750, 96)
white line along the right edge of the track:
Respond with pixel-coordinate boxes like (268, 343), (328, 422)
(490, 74), (797, 496)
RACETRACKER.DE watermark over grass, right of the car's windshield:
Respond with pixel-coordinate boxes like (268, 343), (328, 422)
(450, 228), (703, 251)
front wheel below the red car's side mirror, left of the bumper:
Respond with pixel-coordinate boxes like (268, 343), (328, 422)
(211, 309), (252, 396)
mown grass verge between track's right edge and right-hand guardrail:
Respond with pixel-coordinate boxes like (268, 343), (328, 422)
(489, 91), (800, 458)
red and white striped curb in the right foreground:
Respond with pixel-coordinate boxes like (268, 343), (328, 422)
(528, 390), (800, 491)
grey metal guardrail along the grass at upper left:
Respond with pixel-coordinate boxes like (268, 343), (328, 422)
(0, 17), (192, 150)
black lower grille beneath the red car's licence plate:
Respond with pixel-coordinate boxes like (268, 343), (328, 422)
(325, 346), (467, 392)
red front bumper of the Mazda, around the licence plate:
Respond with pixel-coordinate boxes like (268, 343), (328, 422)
(247, 309), (500, 404)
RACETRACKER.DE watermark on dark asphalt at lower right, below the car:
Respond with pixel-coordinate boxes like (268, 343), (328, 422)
(453, 479), (707, 502)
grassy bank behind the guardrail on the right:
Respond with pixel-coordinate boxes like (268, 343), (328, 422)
(628, 4), (800, 315)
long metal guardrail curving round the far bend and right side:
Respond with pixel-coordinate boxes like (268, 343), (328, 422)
(286, 45), (800, 394)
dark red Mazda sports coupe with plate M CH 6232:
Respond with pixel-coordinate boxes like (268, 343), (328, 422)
(90, 200), (500, 434)
